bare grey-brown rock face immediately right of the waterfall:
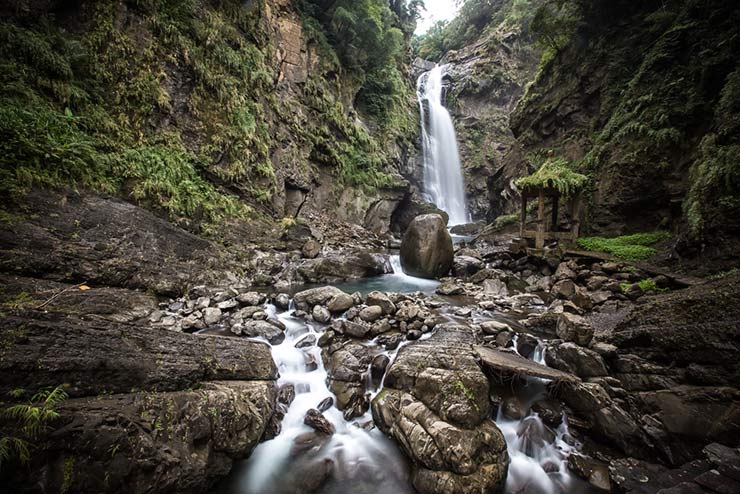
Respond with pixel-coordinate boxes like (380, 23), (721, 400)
(442, 29), (536, 221)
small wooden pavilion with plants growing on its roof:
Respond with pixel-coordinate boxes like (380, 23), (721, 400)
(516, 151), (588, 250)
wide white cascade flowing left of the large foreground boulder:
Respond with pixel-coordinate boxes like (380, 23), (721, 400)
(218, 304), (413, 494)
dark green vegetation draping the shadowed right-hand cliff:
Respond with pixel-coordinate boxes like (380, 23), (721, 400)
(512, 0), (740, 245)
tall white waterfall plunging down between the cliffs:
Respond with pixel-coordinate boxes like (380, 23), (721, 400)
(416, 65), (470, 226)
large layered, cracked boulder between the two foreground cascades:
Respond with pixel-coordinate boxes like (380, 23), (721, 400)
(372, 324), (509, 494)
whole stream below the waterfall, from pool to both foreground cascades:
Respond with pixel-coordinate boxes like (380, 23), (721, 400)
(216, 256), (596, 494)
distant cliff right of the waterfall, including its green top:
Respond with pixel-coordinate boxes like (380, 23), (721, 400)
(415, 0), (542, 221)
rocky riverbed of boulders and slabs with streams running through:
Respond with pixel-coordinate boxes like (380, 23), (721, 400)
(0, 195), (740, 494)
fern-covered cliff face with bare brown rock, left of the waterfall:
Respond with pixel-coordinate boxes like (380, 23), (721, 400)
(0, 0), (418, 233)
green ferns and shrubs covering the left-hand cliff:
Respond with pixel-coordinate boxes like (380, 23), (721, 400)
(0, 0), (419, 234)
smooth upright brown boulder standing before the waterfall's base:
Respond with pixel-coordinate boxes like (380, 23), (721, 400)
(401, 214), (453, 279)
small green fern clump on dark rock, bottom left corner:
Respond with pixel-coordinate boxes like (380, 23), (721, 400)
(0, 386), (67, 467)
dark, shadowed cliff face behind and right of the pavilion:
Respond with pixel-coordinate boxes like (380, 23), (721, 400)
(511, 1), (740, 262)
